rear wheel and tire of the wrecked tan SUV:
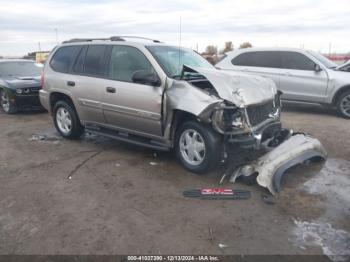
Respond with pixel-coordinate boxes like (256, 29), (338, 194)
(53, 101), (84, 139)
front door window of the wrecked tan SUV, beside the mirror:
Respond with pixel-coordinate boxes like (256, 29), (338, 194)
(109, 46), (154, 82)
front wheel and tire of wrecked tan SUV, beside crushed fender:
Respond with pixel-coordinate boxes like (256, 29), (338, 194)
(175, 121), (222, 174)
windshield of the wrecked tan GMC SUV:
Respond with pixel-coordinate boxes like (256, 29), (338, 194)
(147, 46), (215, 78)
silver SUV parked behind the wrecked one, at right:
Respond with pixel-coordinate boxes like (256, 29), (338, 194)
(216, 48), (350, 118)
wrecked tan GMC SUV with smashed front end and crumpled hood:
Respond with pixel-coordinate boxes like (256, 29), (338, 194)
(40, 37), (326, 192)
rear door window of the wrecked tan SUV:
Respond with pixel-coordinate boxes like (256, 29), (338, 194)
(84, 45), (107, 76)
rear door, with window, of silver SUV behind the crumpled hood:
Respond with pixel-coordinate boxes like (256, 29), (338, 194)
(231, 51), (281, 88)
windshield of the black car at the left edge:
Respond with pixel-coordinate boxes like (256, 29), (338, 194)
(0, 61), (42, 76)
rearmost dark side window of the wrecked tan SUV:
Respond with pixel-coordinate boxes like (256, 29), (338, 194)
(50, 46), (81, 73)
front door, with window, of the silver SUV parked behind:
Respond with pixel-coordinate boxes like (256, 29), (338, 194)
(280, 51), (328, 102)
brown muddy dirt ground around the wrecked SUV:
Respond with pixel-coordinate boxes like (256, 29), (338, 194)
(0, 102), (350, 260)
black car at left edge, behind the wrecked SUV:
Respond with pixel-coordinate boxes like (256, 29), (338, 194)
(0, 59), (43, 114)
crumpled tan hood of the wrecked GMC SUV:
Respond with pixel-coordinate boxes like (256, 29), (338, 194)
(187, 67), (277, 107)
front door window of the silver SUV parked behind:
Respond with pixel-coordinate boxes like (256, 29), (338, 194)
(282, 52), (315, 71)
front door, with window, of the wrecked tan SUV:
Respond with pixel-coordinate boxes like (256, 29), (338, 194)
(102, 45), (163, 136)
